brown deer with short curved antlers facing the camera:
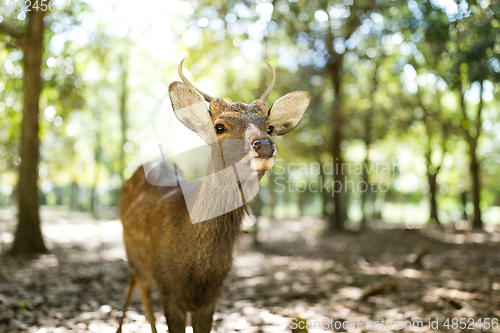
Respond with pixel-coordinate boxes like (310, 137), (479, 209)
(117, 59), (311, 333)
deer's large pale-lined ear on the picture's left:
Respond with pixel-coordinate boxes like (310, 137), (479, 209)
(168, 82), (213, 141)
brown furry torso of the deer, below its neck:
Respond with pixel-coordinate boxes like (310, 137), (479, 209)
(121, 167), (243, 326)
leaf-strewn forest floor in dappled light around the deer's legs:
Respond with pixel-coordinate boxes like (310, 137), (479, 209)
(0, 206), (500, 333)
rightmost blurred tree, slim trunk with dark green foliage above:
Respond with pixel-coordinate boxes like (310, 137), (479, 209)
(448, 4), (500, 229)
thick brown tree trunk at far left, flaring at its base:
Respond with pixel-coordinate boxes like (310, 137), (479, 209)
(8, 10), (48, 255)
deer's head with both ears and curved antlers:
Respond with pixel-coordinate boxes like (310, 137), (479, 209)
(169, 61), (311, 178)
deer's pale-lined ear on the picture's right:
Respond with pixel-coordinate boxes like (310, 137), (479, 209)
(269, 91), (311, 135)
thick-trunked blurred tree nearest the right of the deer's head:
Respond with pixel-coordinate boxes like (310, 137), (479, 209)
(273, 1), (388, 233)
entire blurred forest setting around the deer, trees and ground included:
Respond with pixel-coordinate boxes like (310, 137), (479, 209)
(0, 0), (500, 332)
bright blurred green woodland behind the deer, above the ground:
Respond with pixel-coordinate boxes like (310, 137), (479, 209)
(0, 0), (500, 246)
